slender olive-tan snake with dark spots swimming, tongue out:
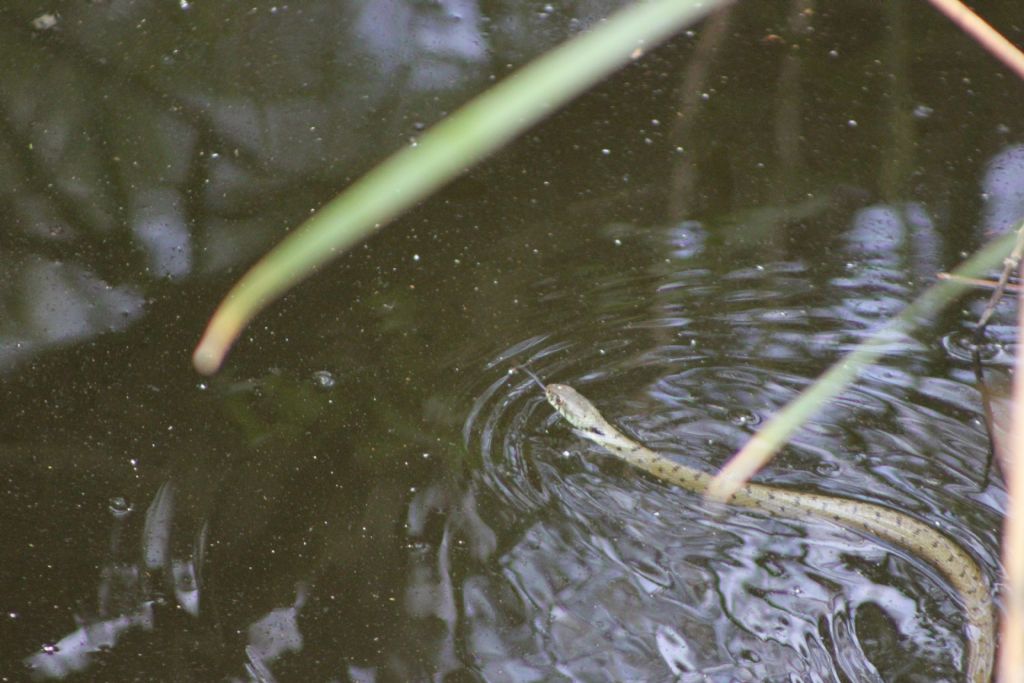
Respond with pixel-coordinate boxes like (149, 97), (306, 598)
(521, 368), (995, 683)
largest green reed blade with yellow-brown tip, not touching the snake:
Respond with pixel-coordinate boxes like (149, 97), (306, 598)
(193, 0), (730, 374)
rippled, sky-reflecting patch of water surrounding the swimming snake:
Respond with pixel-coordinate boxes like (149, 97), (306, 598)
(465, 214), (1000, 681)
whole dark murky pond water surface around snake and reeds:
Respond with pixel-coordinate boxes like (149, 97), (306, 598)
(0, 0), (1024, 681)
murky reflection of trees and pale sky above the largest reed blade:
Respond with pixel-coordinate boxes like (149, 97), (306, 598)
(0, 0), (585, 370)
